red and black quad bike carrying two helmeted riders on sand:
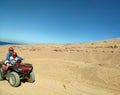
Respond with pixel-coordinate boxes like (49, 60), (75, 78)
(0, 59), (35, 87)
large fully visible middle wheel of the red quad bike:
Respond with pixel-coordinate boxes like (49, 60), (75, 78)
(9, 72), (20, 87)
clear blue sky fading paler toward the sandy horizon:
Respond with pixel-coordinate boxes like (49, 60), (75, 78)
(0, 0), (120, 43)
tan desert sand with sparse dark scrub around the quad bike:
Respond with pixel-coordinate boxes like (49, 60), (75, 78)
(0, 38), (120, 95)
